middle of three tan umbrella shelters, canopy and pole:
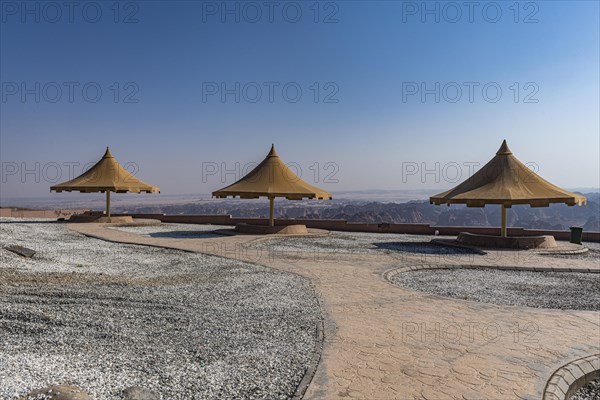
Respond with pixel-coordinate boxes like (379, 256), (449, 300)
(212, 145), (332, 226)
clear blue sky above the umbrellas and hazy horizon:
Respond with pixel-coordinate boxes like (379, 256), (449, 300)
(0, 0), (600, 198)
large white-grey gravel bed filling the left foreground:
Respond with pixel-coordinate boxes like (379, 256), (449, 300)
(0, 219), (321, 400)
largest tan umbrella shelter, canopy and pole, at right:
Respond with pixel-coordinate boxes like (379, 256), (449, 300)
(429, 140), (587, 237)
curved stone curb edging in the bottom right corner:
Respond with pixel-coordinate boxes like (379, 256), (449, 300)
(542, 354), (600, 400)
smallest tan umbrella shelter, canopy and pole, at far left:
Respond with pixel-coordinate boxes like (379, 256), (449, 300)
(50, 147), (160, 217)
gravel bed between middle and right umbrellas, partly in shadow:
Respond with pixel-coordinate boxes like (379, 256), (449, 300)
(251, 232), (475, 255)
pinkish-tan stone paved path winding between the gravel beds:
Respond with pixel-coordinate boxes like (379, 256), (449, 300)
(69, 224), (600, 400)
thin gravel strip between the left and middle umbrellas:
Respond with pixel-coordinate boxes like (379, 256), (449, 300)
(110, 223), (231, 239)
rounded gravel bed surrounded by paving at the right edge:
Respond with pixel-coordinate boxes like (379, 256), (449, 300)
(390, 268), (600, 311)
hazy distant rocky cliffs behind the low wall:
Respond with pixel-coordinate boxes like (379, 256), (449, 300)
(120, 193), (600, 231)
